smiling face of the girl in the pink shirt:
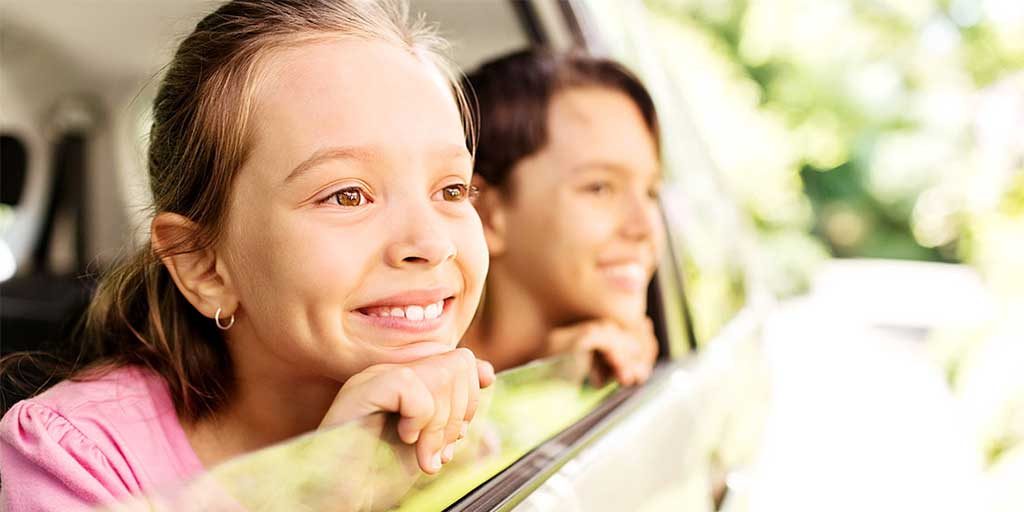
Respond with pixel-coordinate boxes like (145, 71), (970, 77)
(221, 41), (487, 381)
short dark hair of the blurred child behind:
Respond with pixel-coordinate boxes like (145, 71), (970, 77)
(463, 48), (659, 188)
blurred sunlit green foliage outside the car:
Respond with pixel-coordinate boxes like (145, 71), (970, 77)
(645, 0), (1024, 280)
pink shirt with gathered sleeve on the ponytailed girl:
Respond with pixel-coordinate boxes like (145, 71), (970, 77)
(0, 368), (203, 512)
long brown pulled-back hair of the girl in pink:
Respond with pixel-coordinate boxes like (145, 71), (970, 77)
(0, 0), (473, 420)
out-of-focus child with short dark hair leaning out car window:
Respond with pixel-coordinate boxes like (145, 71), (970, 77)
(465, 49), (665, 385)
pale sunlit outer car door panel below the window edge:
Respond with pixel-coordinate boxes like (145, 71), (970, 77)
(513, 333), (774, 512)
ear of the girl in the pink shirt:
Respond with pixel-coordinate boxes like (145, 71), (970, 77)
(150, 212), (239, 318)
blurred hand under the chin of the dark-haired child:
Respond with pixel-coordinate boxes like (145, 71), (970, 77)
(546, 316), (657, 386)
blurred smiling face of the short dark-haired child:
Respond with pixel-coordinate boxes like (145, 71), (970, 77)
(498, 87), (664, 323)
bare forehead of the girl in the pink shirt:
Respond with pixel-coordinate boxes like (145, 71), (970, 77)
(252, 40), (465, 179)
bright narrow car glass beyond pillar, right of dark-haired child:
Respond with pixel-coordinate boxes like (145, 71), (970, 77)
(580, 2), (749, 345)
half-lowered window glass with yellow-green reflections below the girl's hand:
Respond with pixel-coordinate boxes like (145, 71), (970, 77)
(109, 355), (617, 511)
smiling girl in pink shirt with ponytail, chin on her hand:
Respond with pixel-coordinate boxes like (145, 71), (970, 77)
(0, 0), (494, 511)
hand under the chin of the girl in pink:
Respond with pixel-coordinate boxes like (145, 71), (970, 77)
(321, 348), (495, 474)
